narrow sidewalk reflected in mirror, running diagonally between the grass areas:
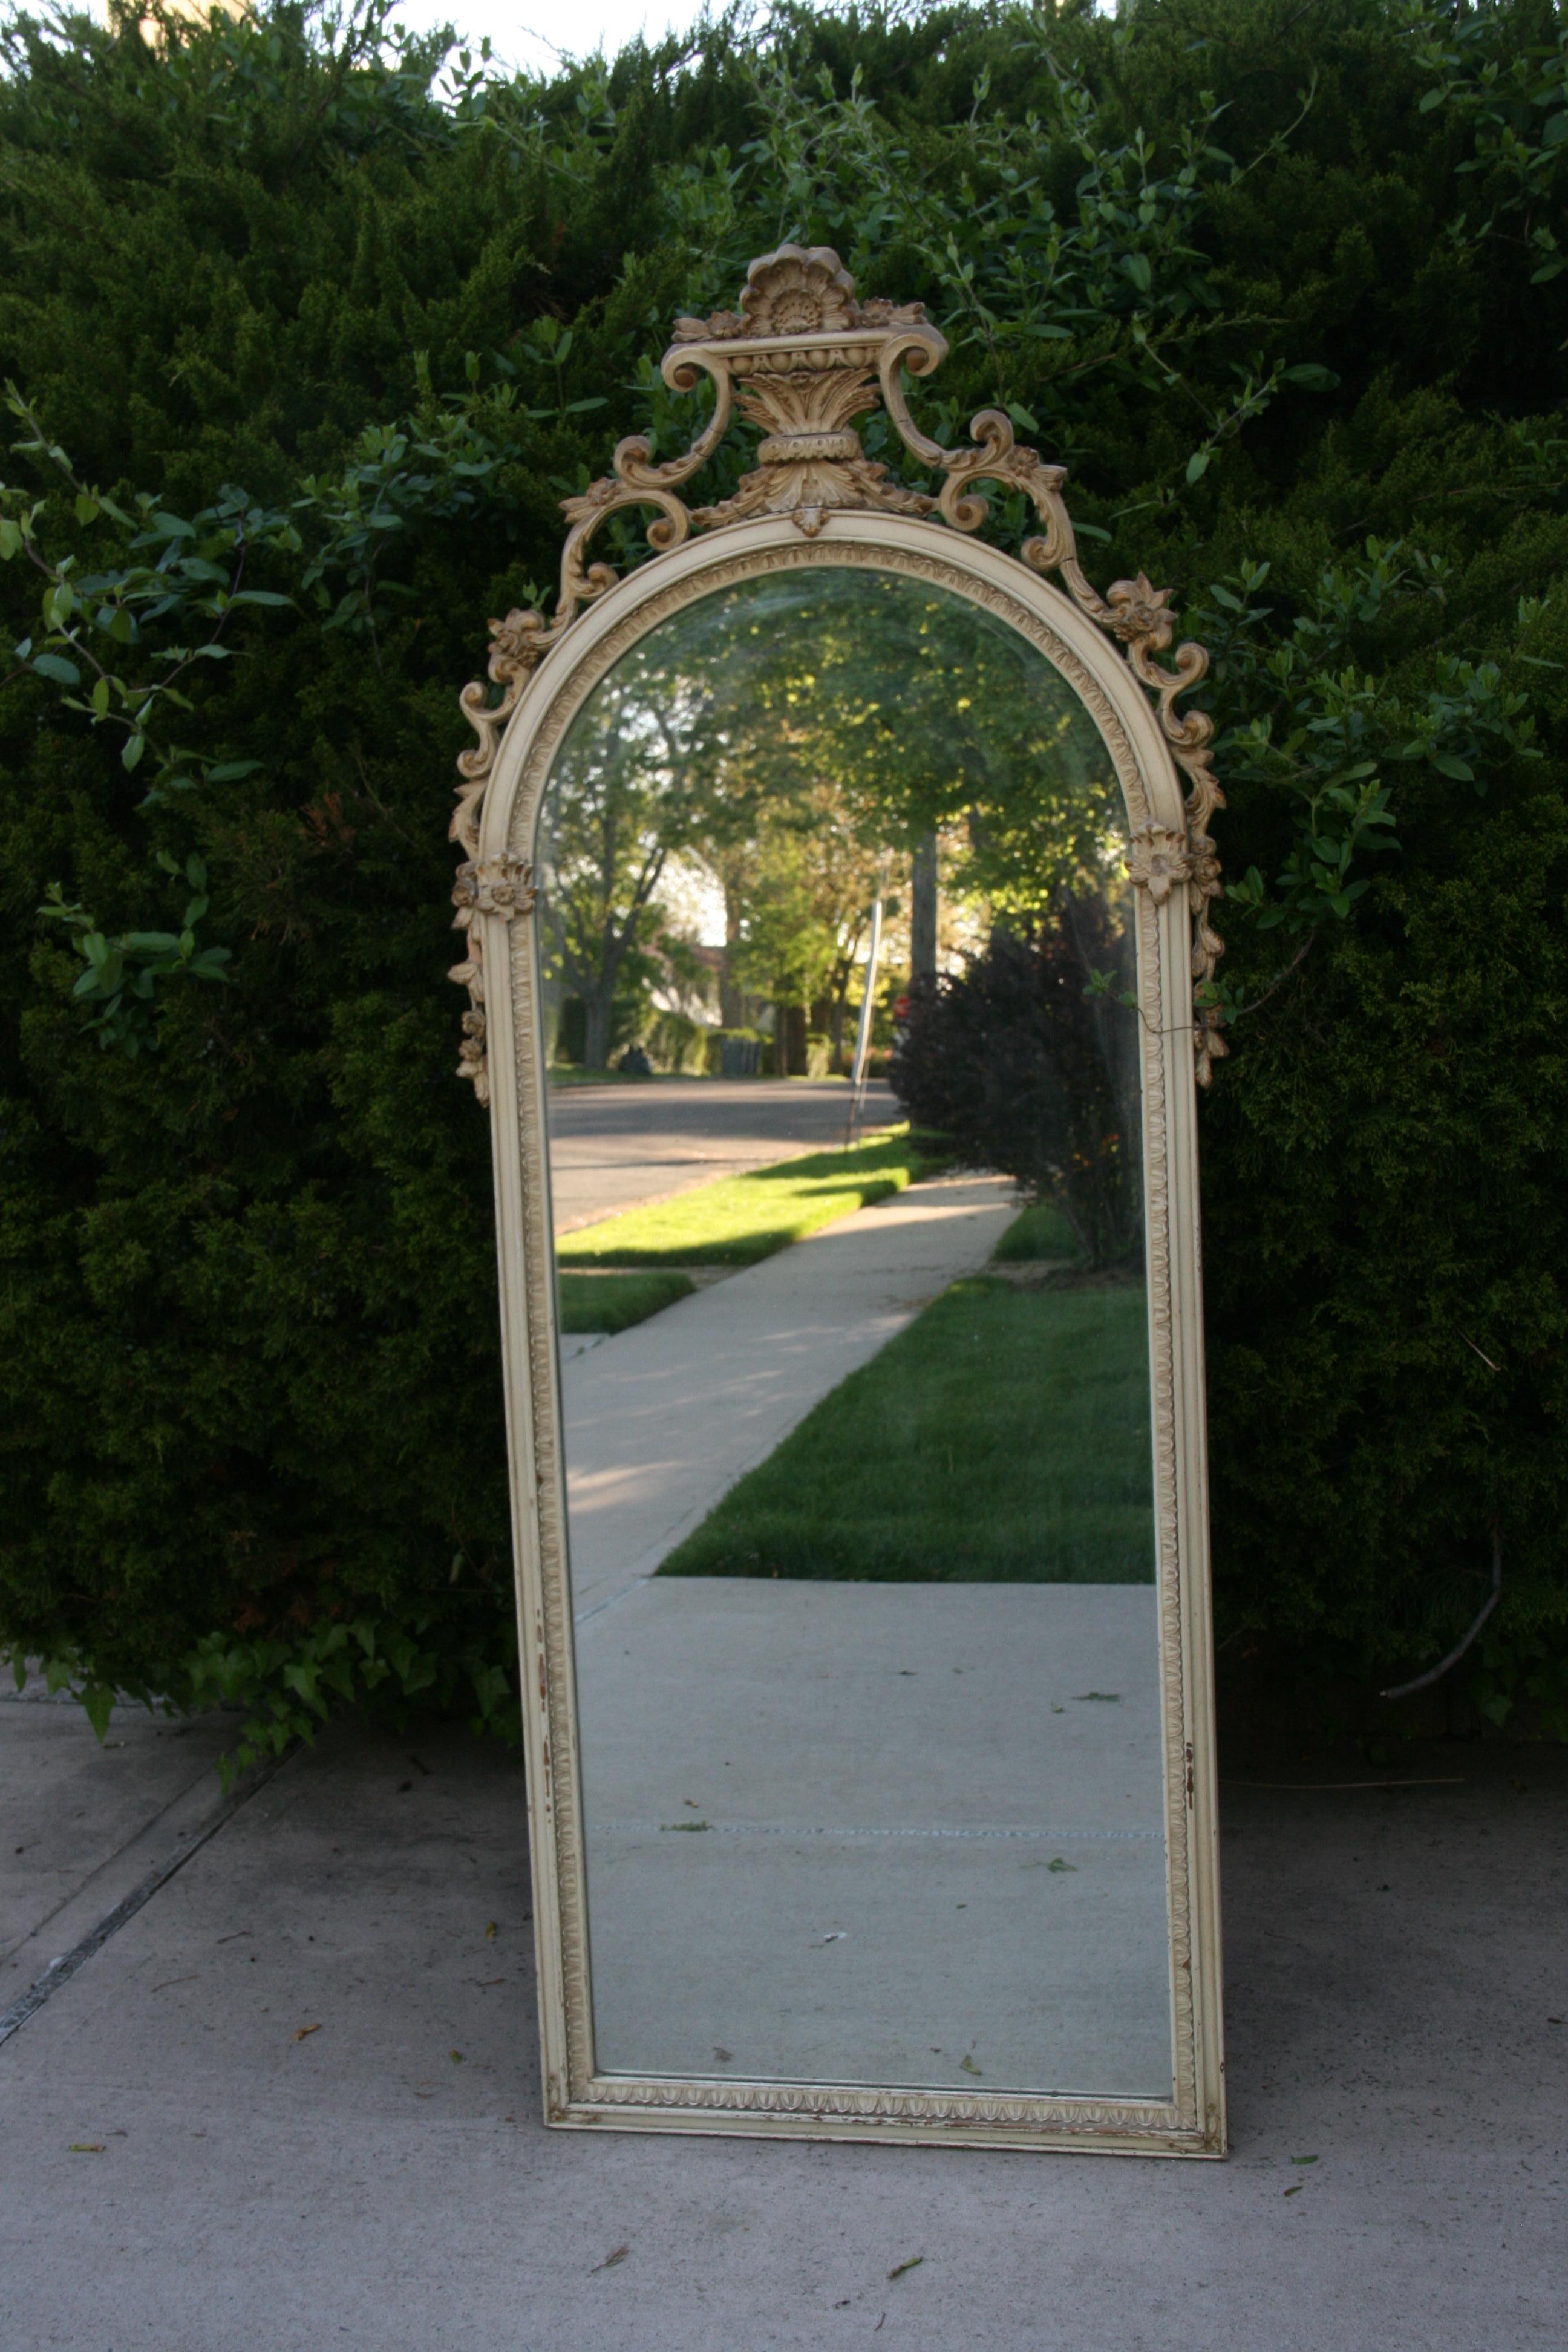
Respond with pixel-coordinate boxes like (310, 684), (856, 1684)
(562, 1176), (1016, 1616)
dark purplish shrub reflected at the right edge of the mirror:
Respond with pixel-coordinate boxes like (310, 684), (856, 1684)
(889, 898), (1143, 1266)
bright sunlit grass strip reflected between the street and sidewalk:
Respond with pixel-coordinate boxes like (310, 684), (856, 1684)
(555, 1129), (933, 1268)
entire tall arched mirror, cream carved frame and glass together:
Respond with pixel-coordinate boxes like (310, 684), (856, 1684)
(454, 247), (1225, 2154)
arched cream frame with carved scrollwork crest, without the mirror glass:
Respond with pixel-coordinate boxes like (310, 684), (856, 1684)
(451, 244), (1225, 2157)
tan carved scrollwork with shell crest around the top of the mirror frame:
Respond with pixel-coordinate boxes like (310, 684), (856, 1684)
(451, 244), (1227, 1101)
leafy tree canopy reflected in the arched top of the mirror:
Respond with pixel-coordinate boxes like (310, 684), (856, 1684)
(541, 567), (1122, 1077)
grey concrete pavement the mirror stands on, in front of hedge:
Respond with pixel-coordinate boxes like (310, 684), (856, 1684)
(0, 1700), (1568, 2352)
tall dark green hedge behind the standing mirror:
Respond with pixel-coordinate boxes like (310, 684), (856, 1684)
(0, 0), (1568, 1738)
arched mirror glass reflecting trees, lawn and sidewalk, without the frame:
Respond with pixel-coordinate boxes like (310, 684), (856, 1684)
(536, 564), (1171, 2098)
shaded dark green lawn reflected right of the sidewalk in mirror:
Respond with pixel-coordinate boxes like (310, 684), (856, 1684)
(658, 1277), (1154, 1586)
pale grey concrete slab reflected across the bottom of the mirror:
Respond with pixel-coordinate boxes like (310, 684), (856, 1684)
(578, 1576), (1171, 2098)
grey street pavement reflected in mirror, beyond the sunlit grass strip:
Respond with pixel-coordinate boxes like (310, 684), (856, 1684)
(550, 1077), (900, 1232)
